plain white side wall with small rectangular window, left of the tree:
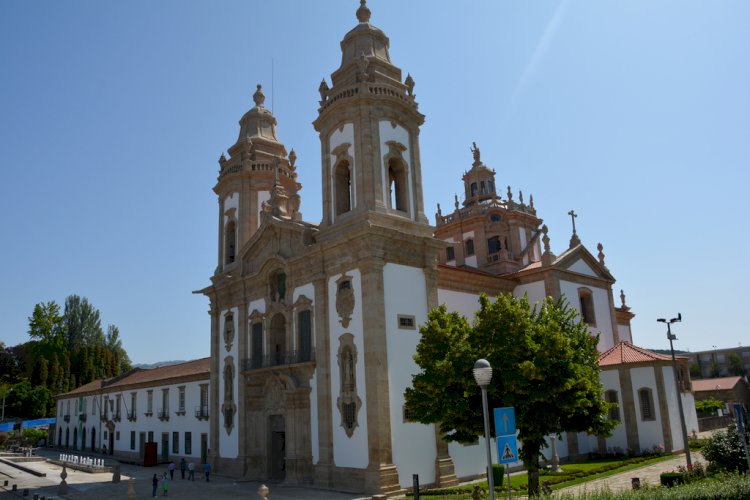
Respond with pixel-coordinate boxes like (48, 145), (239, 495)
(383, 263), (437, 487)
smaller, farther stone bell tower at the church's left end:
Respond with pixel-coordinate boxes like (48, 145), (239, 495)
(214, 85), (302, 273)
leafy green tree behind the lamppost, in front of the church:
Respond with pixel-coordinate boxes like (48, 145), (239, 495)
(404, 295), (615, 494)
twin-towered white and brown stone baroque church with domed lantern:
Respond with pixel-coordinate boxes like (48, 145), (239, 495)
(200, 0), (697, 494)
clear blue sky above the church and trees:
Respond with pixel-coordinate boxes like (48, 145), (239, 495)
(0, 0), (750, 362)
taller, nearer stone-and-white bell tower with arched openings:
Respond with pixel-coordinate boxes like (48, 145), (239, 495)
(313, 0), (428, 229)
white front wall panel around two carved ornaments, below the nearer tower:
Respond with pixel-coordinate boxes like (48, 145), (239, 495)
(328, 269), (368, 469)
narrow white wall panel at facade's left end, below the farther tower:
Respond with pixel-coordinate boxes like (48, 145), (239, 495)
(219, 307), (242, 458)
